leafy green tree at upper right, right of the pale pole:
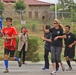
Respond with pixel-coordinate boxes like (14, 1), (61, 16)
(58, 0), (76, 22)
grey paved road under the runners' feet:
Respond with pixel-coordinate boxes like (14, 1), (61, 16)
(0, 61), (76, 75)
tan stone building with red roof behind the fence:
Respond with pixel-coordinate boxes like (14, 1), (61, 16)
(2, 0), (54, 20)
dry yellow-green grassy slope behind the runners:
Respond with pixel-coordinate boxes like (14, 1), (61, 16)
(0, 21), (76, 60)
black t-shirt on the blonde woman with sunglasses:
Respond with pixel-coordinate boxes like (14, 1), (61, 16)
(49, 28), (64, 47)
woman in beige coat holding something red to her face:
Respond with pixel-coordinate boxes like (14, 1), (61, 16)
(18, 27), (28, 64)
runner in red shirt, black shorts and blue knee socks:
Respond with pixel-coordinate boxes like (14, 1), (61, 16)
(0, 17), (22, 73)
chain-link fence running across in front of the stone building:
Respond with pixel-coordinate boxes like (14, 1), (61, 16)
(0, 10), (76, 25)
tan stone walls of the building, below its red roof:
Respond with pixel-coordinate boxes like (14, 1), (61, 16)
(3, 3), (50, 20)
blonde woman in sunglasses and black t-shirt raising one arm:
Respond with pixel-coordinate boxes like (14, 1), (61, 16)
(43, 19), (66, 75)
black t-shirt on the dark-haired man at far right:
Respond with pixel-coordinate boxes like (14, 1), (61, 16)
(64, 33), (76, 47)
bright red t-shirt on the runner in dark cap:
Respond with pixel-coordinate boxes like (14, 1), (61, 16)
(2, 26), (18, 50)
